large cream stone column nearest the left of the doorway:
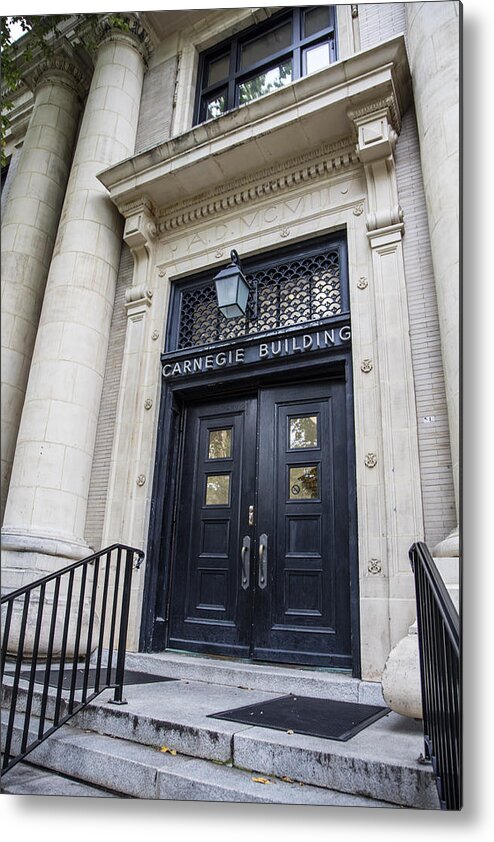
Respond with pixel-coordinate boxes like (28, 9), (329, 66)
(2, 19), (151, 589)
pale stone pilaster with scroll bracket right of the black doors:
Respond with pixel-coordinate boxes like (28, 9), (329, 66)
(351, 103), (423, 646)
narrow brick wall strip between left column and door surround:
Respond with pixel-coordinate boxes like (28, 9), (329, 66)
(85, 243), (134, 550)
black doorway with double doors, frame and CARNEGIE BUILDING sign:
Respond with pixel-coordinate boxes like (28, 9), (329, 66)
(140, 233), (360, 676)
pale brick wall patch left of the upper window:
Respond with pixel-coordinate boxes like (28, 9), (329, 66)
(135, 56), (177, 154)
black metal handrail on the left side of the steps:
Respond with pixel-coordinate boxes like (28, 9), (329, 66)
(1, 544), (144, 774)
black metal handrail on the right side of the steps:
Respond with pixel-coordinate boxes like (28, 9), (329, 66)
(409, 542), (462, 810)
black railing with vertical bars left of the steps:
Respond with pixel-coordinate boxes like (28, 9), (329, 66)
(0, 544), (144, 776)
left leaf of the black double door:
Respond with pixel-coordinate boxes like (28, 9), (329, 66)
(169, 399), (256, 656)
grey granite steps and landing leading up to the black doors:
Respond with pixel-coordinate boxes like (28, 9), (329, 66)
(0, 656), (438, 809)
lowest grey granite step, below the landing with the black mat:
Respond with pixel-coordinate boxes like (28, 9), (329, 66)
(4, 712), (396, 808)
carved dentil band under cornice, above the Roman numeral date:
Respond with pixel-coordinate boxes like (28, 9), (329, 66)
(157, 140), (358, 233)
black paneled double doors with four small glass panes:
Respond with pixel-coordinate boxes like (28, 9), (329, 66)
(168, 381), (352, 669)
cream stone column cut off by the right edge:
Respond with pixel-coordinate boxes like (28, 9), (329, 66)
(405, 0), (460, 556)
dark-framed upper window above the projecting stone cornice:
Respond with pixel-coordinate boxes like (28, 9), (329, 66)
(194, 6), (336, 123)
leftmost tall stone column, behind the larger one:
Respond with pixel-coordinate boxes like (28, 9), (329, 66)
(1, 55), (89, 517)
